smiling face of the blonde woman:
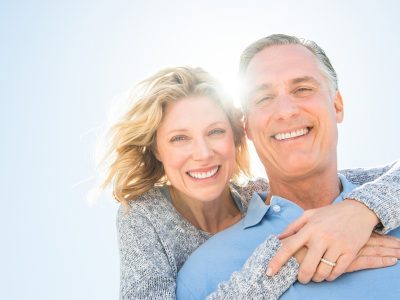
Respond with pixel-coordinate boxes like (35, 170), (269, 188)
(157, 96), (236, 202)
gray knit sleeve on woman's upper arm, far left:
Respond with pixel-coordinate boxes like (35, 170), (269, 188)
(117, 208), (176, 300)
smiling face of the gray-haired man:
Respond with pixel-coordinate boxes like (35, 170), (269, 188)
(245, 45), (343, 180)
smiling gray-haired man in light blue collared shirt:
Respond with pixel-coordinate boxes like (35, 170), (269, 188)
(177, 35), (400, 299)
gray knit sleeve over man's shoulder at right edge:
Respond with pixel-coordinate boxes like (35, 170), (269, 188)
(340, 161), (400, 233)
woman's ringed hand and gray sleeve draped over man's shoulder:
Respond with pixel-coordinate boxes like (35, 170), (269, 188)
(269, 161), (400, 283)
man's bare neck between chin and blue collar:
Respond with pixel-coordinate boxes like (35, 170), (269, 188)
(266, 170), (342, 210)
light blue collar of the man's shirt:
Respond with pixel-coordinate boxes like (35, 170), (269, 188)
(243, 174), (356, 229)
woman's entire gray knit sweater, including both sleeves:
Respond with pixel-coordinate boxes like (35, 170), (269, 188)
(117, 161), (400, 299)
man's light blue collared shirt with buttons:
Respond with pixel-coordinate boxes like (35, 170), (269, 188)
(177, 174), (400, 299)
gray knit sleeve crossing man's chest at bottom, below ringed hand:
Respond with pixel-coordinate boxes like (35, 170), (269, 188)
(207, 236), (299, 300)
